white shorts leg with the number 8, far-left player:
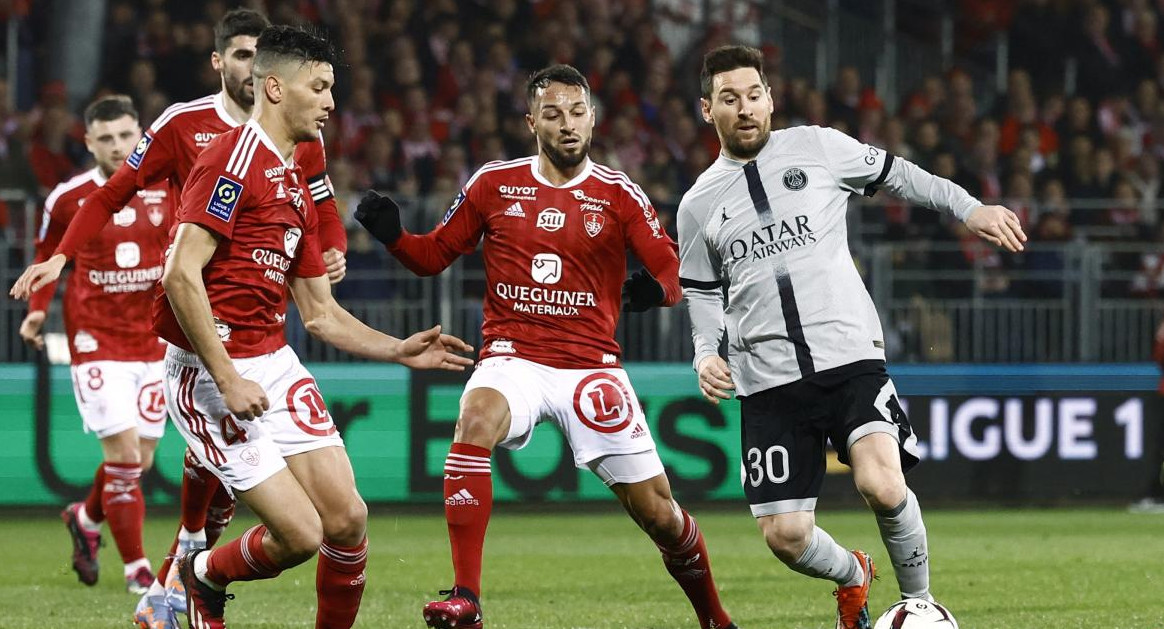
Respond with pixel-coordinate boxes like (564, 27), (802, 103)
(71, 360), (140, 439)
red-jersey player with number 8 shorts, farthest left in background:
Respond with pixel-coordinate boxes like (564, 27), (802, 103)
(20, 96), (173, 594)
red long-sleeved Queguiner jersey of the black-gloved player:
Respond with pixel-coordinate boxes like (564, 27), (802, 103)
(389, 157), (681, 369)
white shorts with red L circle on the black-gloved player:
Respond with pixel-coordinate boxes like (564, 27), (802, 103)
(464, 356), (662, 475)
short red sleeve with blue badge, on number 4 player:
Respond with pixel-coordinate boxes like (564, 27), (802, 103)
(178, 151), (250, 238)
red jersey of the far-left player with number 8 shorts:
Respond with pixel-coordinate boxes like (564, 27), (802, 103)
(28, 168), (173, 365)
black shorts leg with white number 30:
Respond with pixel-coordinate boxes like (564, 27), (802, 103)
(740, 383), (825, 518)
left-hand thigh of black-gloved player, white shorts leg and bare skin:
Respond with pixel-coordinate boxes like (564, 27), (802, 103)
(456, 356), (549, 450)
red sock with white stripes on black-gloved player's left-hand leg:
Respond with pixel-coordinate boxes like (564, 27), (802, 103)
(445, 443), (494, 596)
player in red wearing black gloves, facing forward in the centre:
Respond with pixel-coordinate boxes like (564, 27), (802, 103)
(356, 65), (734, 629)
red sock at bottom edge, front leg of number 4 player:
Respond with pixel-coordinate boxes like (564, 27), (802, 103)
(315, 537), (368, 629)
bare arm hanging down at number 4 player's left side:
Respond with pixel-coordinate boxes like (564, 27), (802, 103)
(162, 222), (268, 419)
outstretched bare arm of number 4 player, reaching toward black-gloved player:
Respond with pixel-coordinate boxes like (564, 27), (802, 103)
(291, 270), (473, 372)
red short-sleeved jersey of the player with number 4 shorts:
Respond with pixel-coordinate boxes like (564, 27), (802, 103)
(154, 120), (327, 358)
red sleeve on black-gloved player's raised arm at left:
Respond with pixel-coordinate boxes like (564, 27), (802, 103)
(388, 186), (485, 275)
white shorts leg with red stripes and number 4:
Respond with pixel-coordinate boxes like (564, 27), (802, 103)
(165, 347), (286, 492)
